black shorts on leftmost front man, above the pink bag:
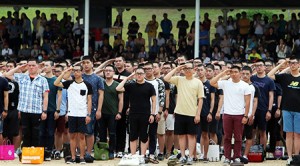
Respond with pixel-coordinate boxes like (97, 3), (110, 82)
(3, 109), (20, 138)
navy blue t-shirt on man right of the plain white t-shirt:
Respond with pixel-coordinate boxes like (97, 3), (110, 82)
(251, 75), (276, 111)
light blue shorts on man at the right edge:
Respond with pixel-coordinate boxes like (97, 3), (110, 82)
(282, 110), (300, 134)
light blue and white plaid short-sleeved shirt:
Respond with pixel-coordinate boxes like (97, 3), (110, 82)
(14, 73), (49, 114)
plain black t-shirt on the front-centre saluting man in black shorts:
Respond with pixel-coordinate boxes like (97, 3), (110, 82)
(124, 82), (156, 115)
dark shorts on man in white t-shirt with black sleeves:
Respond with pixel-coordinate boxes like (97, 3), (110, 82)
(68, 116), (87, 133)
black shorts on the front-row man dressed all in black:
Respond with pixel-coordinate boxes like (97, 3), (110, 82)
(128, 114), (149, 143)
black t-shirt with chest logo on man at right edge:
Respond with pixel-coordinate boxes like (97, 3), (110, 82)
(275, 74), (300, 112)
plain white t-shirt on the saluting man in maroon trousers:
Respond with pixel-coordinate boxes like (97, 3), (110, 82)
(218, 80), (251, 115)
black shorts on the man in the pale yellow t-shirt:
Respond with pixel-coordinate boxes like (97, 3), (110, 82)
(174, 114), (198, 135)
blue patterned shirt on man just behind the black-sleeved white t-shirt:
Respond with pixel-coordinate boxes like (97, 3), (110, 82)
(82, 73), (104, 112)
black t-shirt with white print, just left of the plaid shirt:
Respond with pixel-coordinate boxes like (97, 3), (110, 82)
(7, 78), (20, 110)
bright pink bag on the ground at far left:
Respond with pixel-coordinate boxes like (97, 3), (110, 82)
(0, 140), (15, 160)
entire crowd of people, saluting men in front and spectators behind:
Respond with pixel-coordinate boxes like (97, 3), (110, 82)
(0, 11), (300, 165)
